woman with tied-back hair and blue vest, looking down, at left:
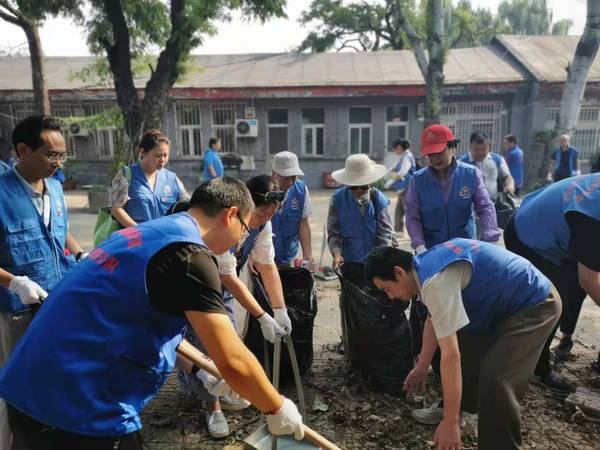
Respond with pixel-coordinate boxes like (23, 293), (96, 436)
(109, 130), (190, 228)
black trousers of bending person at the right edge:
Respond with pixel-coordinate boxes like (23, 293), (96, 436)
(504, 214), (581, 376)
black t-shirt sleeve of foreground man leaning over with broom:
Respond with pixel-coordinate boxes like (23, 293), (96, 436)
(146, 243), (227, 316)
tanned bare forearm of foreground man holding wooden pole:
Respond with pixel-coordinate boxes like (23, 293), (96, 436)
(186, 311), (283, 413)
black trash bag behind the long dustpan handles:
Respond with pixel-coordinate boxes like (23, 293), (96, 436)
(244, 267), (317, 381)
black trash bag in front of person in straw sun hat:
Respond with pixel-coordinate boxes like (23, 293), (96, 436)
(340, 263), (413, 396)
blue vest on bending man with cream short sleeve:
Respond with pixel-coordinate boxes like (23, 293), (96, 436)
(414, 239), (551, 333)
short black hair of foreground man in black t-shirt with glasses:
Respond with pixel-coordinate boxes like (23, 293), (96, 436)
(190, 177), (253, 217)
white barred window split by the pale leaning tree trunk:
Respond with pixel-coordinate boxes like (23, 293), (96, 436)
(546, 106), (600, 161)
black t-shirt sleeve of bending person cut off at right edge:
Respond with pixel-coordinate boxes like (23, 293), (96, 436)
(566, 212), (600, 272)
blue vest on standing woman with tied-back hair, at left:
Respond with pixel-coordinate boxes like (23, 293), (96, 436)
(125, 163), (179, 223)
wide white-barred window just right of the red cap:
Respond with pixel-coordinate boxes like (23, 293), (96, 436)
(441, 102), (505, 157)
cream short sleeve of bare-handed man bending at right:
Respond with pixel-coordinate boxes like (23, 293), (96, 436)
(421, 261), (473, 339)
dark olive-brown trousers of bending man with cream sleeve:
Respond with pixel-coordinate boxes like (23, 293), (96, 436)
(458, 296), (561, 450)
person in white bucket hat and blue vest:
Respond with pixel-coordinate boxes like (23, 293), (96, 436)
(271, 151), (313, 270)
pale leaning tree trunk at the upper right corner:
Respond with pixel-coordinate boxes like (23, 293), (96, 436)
(554, 0), (600, 135)
